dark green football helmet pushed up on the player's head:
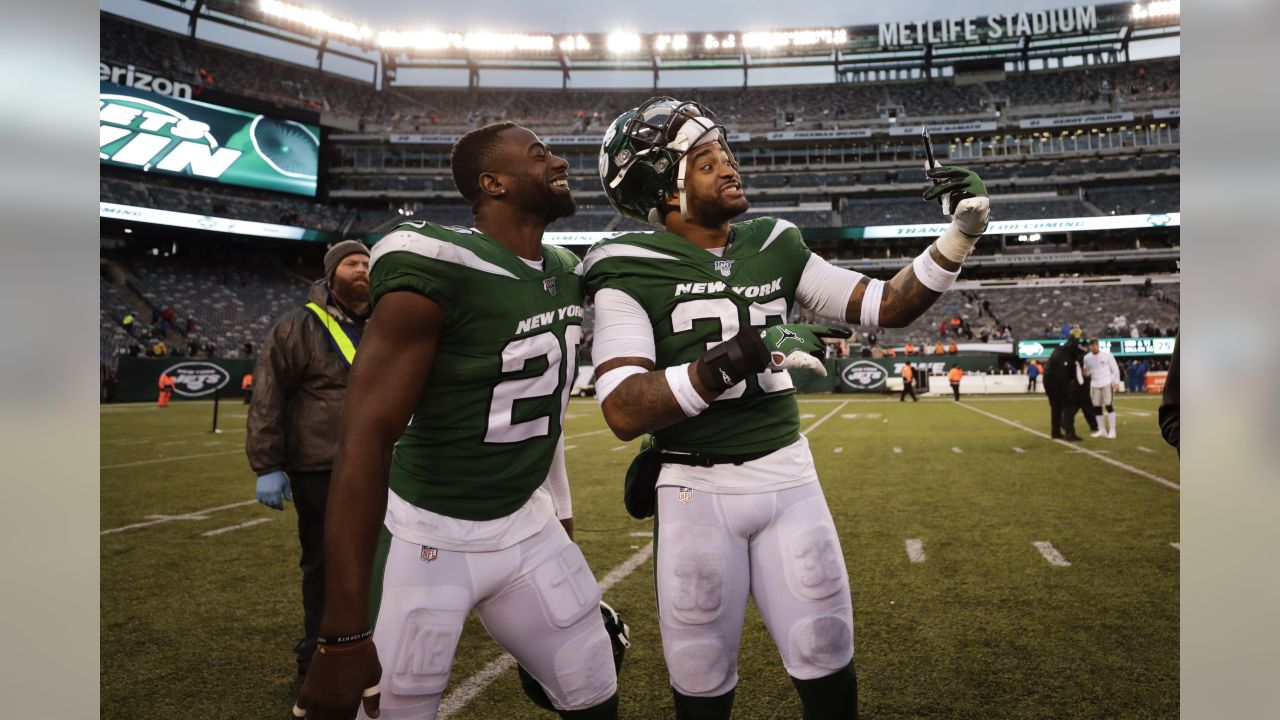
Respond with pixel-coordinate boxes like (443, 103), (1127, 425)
(600, 97), (733, 227)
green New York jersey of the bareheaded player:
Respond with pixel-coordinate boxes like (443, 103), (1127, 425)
(370, 222), (582, 520)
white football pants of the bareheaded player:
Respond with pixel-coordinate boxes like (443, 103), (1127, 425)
(358, 518), (618, 720)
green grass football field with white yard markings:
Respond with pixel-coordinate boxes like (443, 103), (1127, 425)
(101, 395), (1179, 720)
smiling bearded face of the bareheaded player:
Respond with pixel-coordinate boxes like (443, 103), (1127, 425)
(488, 126), (577, 223)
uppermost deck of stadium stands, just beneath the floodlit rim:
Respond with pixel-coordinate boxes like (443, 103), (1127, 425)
(101, 13), (1180, 133)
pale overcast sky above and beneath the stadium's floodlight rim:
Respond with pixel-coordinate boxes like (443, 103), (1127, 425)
(100, 0), (1178, 87)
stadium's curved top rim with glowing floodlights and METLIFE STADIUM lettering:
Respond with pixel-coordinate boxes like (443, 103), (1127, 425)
(132, 0), (1180, 86)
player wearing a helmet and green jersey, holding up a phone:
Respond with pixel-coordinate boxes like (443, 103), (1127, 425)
(584, 97), (988, 720)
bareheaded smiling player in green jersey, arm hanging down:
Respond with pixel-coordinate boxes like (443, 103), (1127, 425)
(294, 123), (618, 720)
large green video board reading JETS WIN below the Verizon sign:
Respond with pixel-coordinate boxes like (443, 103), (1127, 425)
(99, 82), (320, 197)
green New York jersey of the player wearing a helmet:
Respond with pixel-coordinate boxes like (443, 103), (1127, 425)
(582, 218), (810, 455)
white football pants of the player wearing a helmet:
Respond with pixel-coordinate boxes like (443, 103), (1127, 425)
(655, 476), (854, 697)
